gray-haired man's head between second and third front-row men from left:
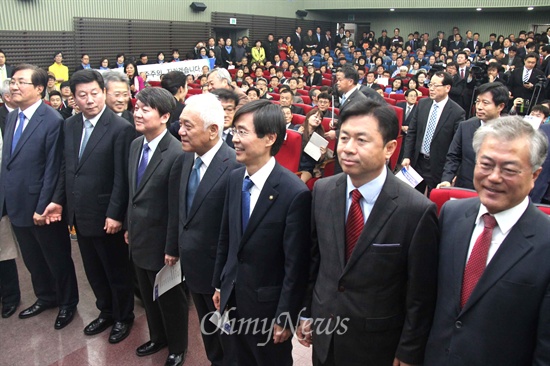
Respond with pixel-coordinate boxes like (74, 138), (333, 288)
(103, 71), (134, 124)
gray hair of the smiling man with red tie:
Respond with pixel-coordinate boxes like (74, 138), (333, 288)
(472, 116), (548, 172)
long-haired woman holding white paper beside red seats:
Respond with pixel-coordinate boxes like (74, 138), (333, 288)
(298, 108), (327, 183)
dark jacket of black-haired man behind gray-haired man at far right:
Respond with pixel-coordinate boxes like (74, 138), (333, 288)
(441, 117), (481, 189)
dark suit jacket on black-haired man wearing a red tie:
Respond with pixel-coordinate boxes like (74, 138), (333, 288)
(306, 170), (439, 366)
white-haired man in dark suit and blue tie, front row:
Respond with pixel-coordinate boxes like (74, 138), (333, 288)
(178, 93), (239, 366)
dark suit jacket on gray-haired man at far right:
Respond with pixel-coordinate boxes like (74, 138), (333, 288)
(430, 198), (550, 366)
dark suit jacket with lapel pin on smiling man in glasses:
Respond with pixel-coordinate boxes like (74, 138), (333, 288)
(212, 163), (311, 327)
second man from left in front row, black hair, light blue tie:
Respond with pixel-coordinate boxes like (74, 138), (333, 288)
(48, 70), (135, 343)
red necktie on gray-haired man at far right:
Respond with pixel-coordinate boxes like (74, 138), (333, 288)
(460, 213), (497, 308)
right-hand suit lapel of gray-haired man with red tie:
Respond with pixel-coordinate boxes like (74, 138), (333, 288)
(462, 203), (538, 312)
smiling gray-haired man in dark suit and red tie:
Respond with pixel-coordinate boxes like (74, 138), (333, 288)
(424, 116), (550, 366)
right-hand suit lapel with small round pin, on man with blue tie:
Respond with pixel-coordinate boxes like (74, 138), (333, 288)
(239, 163), (283, 249)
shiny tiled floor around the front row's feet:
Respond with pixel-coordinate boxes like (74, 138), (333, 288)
(0, 242), (311, 366)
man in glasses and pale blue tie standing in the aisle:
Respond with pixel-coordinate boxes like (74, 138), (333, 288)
(401, 71), (465, 194)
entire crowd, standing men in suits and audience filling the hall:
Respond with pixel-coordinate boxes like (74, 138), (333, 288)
(0, 22), (550, 366)
